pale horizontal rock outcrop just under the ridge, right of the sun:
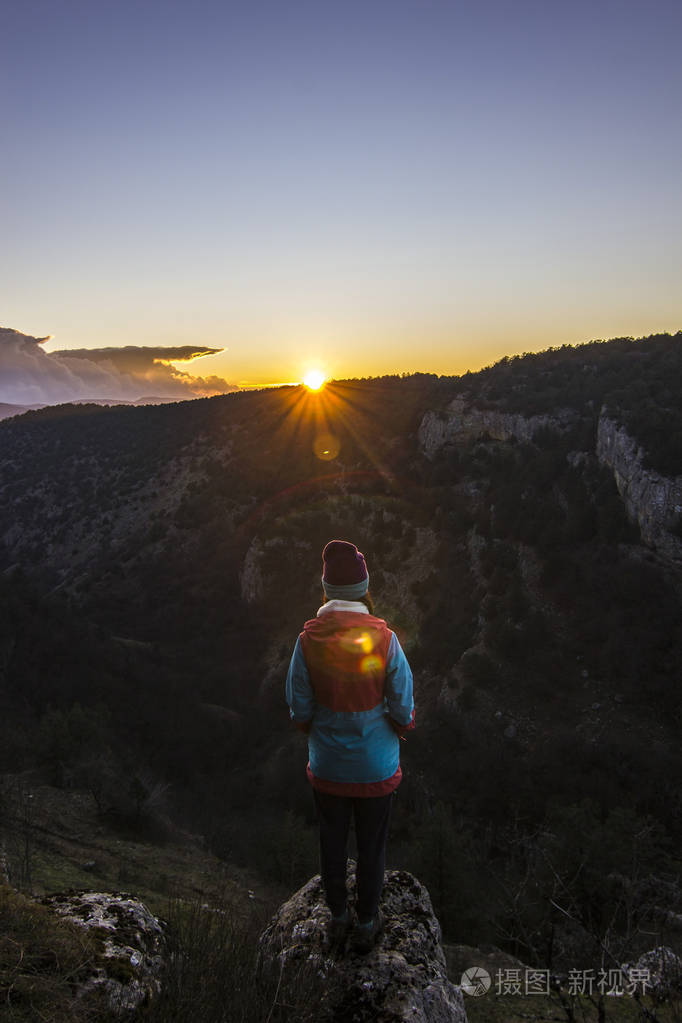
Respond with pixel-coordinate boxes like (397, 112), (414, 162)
(418, 398), (575, 458)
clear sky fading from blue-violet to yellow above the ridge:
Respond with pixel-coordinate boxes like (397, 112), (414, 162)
(0, 0), (682, 384)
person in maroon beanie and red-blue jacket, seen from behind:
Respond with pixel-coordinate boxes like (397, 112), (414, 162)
(286, 540), (414, 951)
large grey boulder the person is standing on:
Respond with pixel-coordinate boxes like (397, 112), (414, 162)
(259, 863), (466, 1023)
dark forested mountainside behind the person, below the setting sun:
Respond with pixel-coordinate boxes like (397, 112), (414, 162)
(0, 333), (682, 965)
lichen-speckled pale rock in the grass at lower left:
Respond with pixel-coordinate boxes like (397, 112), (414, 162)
(42, 892), (166, 1015)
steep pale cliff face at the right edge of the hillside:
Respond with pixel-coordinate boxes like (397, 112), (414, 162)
(597, 412), (682, 564)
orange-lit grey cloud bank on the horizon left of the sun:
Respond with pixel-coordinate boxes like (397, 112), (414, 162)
(0, 327), (237, 405)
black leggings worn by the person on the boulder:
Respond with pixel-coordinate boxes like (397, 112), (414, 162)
(313, 789), (394, 924)
